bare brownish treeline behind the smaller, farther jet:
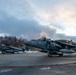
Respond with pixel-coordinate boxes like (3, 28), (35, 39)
(0, 36), (26, 47)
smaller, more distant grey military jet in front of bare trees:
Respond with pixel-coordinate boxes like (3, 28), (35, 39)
(0, 45), (24, 54)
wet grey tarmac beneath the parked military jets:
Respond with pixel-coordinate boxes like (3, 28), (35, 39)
(0, 52), (76, 75)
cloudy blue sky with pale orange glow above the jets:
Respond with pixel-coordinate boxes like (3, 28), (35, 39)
(0, 0), (76, 41)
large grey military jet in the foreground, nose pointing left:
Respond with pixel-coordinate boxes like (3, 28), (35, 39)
(25, 37), (76, 56)
